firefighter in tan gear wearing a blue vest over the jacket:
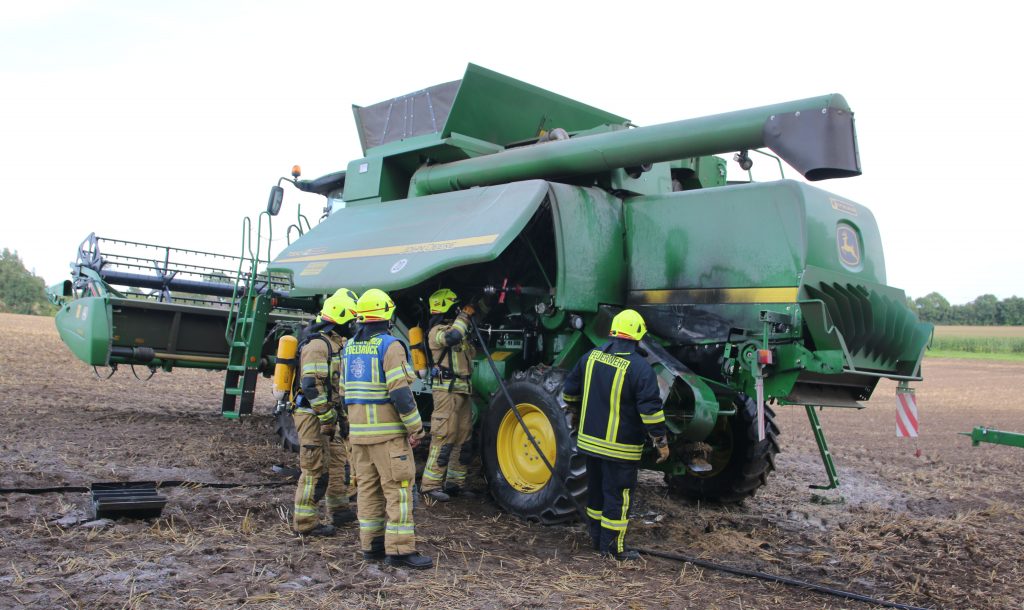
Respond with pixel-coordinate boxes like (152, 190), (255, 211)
(341, 289), (434, 569)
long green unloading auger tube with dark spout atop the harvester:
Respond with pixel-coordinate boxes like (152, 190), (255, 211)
(413, 93), (860, 195)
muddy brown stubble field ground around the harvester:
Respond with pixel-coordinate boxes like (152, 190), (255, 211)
(0, 315), (1024, 608)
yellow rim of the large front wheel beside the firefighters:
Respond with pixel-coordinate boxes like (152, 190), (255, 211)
(498, 402), (558, 493)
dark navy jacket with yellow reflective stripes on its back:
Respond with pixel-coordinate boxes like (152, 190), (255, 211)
(562, 339), (667, 462)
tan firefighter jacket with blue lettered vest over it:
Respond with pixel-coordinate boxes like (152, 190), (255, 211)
(339, 324), (423, 445)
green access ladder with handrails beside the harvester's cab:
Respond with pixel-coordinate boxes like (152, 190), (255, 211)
(220, 212), (273, 419)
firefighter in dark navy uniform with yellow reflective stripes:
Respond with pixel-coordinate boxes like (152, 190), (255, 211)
(562, 309), (669, 561)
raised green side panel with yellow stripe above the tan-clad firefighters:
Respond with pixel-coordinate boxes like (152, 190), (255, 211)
(269, 180), (548, 296)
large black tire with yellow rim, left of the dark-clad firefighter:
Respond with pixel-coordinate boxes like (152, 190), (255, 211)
(480, 367), (587, 525)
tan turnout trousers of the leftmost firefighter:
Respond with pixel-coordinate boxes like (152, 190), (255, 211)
(292, 410), (349, 532)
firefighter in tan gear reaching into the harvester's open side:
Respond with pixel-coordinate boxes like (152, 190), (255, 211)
(420, 289), (474, 502)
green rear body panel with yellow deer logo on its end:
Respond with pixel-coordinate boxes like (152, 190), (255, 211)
(626, 180), (885, 292)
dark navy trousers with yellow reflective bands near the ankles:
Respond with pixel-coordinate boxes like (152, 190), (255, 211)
(587, 455), (640, 554)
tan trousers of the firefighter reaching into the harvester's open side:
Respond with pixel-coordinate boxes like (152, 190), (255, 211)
(420, 389), (473, 492)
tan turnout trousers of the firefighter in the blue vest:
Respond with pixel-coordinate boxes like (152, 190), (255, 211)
(352, 436), (416, 555)
